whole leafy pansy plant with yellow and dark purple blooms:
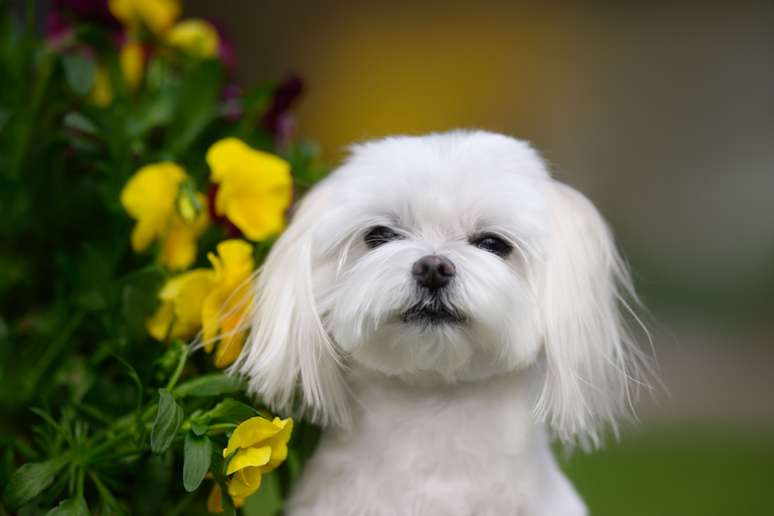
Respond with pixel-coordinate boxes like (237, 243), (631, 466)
(0, 0), (323, 514)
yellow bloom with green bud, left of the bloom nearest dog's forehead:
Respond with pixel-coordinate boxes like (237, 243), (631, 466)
(121, 161), (209, 269)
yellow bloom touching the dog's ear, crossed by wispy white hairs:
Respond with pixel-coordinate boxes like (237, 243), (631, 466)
(202, 240), (255, 367)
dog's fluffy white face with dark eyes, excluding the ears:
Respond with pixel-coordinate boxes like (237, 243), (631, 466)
(312, 134), (548, 381)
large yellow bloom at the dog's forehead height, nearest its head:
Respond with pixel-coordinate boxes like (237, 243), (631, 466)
(207, 138), (293, 241)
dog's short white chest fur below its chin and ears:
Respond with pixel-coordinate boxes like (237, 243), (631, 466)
(288, 375), (586, 516)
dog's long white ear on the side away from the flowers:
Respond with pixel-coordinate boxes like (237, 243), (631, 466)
(536, 181), (643, 446)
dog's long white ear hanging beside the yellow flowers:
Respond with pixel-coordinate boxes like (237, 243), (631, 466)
(233, 187), (348, 425)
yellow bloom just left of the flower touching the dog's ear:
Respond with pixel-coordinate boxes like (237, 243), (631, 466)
(146, 269), (213, 342)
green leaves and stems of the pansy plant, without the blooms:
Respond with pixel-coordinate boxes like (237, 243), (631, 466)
(0, 1), (324, 515)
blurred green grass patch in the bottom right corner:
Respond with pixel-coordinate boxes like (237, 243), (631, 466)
(563, 425), (774, 516)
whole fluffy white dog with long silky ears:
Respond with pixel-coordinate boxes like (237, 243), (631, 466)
(234, 131), (640, 516)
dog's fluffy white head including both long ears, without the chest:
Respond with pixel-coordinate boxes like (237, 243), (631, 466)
(235, 132), (648, 441)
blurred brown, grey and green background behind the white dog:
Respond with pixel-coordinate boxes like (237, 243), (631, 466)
(186, 0), (774, 516)
